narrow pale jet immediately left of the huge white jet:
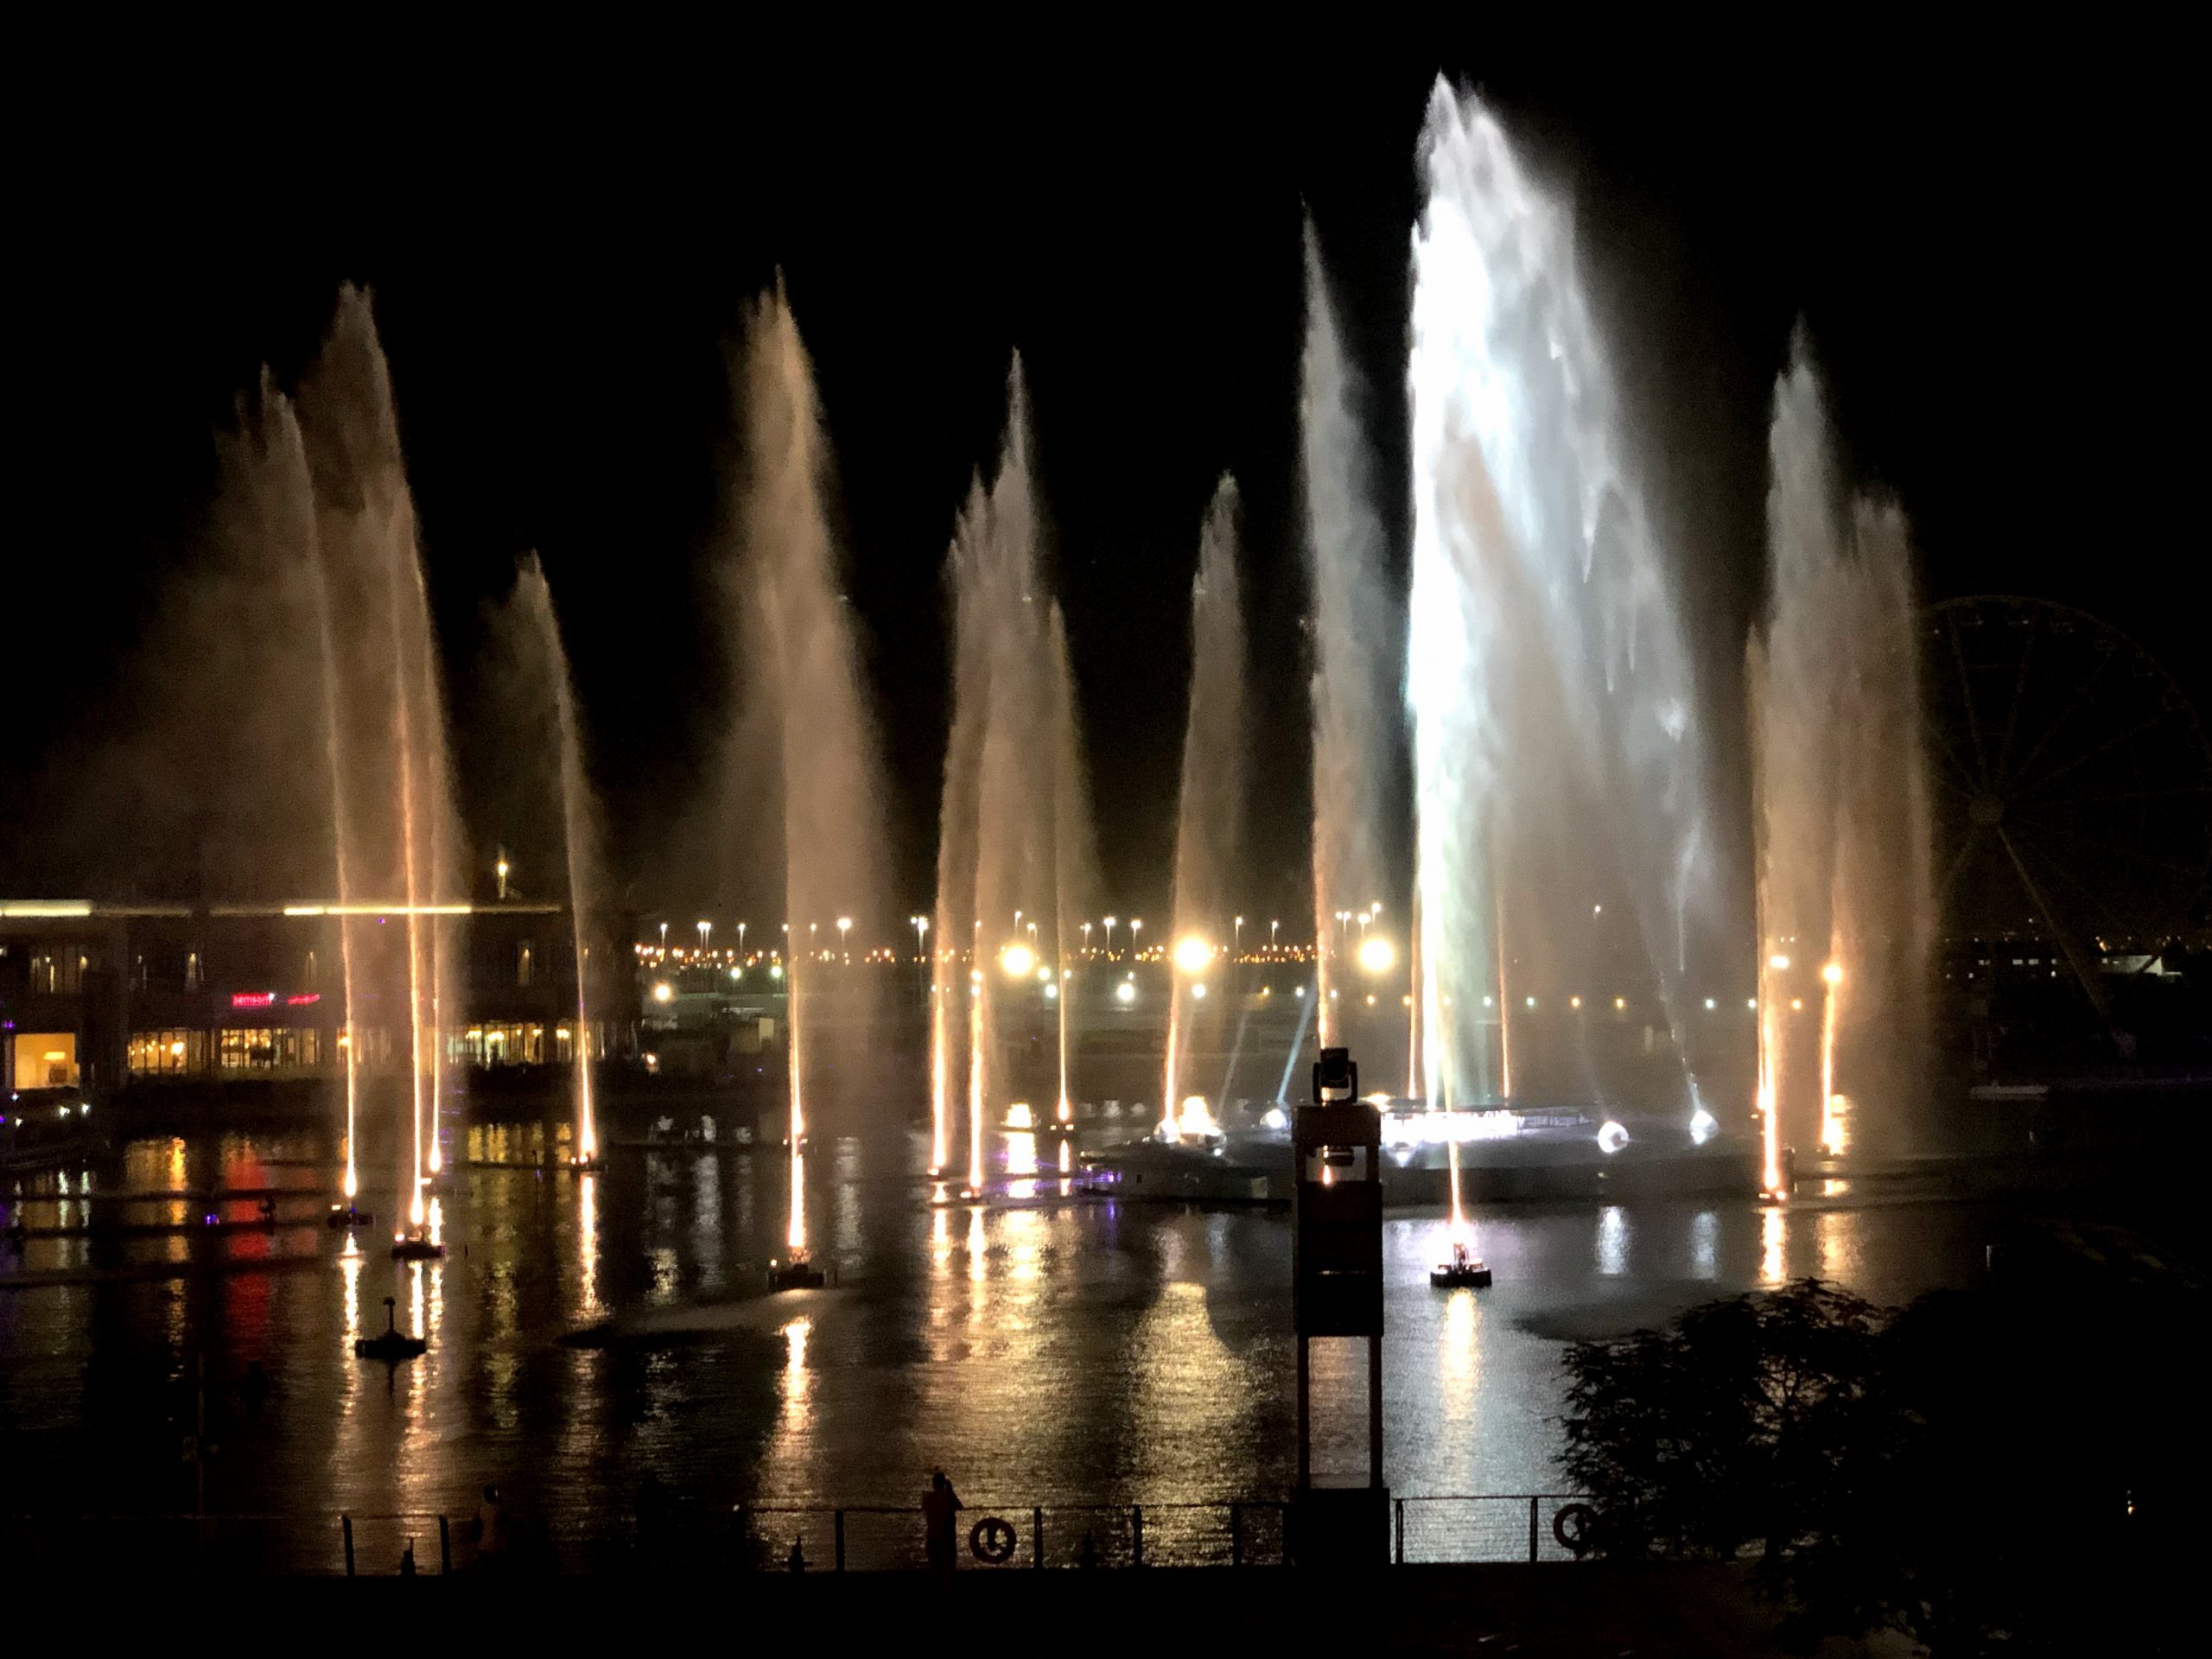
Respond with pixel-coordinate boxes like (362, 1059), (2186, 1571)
(1303, 219), (1389, 1057)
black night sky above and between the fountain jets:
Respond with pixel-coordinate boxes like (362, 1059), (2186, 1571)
(13, 39), (2208, 916)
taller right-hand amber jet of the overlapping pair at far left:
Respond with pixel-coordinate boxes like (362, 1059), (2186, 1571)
(299, 288), (465, 1225)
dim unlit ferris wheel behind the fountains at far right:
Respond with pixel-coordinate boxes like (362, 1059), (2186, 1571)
(1923, 595), (2212, 971)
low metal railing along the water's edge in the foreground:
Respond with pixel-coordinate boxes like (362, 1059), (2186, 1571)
(0, 1493), (1586, 1577)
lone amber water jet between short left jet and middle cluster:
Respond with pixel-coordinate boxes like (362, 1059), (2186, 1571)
(732, 283), (885, 1255)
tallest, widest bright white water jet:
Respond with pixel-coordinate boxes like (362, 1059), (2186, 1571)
(1407, 82), (1712, 1117)
